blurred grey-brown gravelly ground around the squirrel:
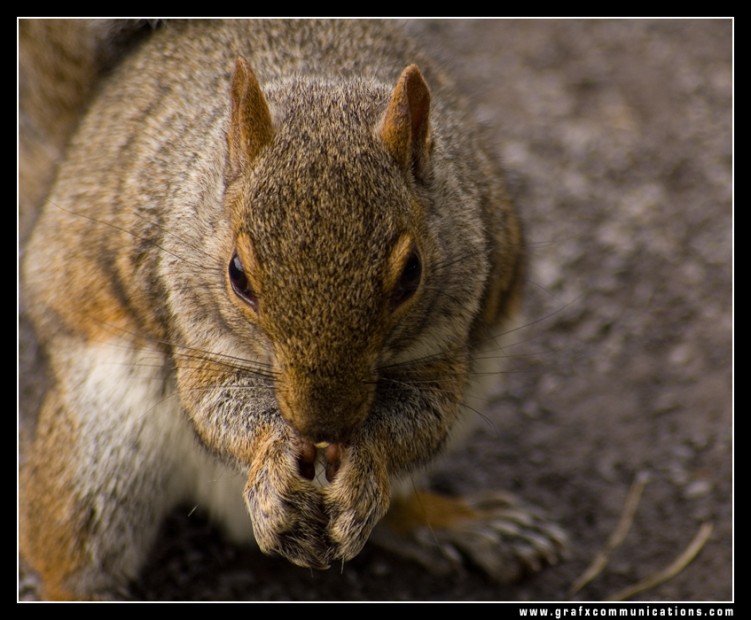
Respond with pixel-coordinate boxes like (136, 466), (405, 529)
(19, 20), (734, 601)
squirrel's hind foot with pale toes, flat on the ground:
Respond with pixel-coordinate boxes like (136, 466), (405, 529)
(373, 492), (568, 583)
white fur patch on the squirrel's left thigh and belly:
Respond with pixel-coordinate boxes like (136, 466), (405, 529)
(64, 340), (252, 542)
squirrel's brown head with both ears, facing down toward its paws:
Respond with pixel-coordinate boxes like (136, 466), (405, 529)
(220, 58), (436, 443)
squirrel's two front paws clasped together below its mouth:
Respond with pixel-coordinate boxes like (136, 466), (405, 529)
(244, 437), (389, 569)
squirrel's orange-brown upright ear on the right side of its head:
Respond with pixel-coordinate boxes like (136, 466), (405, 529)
(379, 65), (430, 180)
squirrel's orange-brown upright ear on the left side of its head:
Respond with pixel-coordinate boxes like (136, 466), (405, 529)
(227, 57), (274, 176)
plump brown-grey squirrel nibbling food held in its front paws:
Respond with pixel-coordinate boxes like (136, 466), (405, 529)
(19, 20), (565, 599)
